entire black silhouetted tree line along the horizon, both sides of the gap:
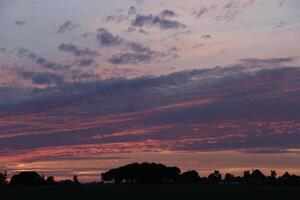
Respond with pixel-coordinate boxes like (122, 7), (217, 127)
(0, 162), (300, 187)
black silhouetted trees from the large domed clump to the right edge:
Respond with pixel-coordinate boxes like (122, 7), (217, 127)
(101, 163), (300, 185)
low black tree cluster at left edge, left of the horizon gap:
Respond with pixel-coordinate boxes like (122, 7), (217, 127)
(0, 171), (81, 187)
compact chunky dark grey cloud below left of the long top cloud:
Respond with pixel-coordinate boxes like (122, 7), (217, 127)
(97, 28), (124, 47)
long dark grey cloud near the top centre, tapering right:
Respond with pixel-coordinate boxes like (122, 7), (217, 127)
(131, 14), (186, 30)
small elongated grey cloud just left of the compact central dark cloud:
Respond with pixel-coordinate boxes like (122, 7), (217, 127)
(58, 43), (100, 56)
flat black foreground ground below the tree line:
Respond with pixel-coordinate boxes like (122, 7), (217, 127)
(0, 185), (300, 200)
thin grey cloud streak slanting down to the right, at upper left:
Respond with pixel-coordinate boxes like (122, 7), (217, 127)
(17, 48), (71, 70)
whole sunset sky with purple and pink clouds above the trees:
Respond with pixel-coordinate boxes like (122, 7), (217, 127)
(0, 0), (300, 181)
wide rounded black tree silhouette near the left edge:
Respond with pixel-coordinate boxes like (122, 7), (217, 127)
(9, 172), (45, 186)
